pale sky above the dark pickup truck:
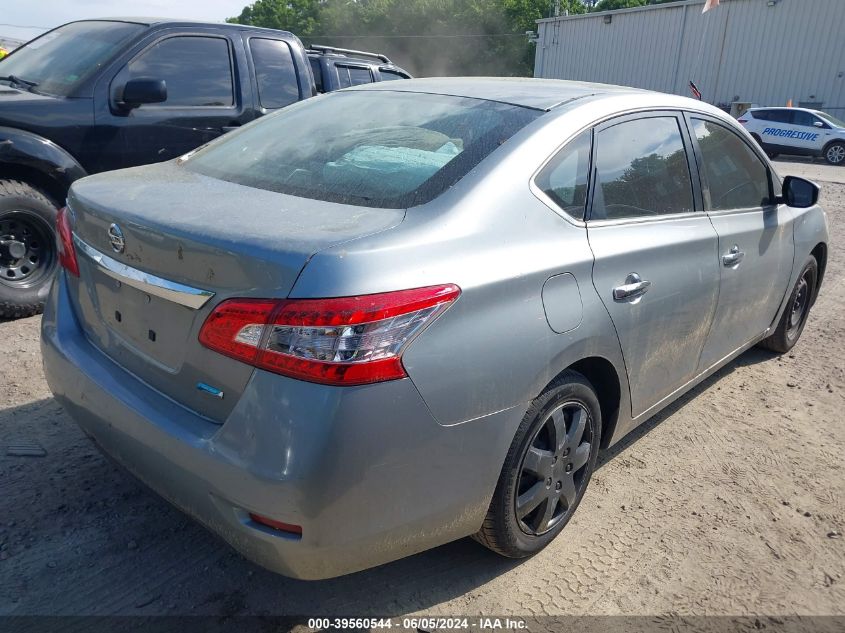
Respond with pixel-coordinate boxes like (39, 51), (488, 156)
(0, 0), (253, 40)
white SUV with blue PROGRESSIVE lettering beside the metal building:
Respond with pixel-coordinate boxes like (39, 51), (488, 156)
(739, 108), (845, 165)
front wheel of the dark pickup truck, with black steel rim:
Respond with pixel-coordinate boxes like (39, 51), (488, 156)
(0, 180), (58, 319)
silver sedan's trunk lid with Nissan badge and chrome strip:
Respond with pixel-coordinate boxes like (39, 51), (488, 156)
(68, 163), (404, 422)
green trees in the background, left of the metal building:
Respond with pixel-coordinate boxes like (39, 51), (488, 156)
(229, 0), (586, 76)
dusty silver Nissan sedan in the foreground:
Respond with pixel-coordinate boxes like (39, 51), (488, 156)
(42, 79), (828, 579)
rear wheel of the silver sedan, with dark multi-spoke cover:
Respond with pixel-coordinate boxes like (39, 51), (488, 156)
(473, 371), (601, 558)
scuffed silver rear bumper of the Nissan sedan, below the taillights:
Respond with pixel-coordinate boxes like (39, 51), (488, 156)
(41, 274), (522, 579)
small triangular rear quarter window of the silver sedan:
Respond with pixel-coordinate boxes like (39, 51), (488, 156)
(535, 130), (593, 220)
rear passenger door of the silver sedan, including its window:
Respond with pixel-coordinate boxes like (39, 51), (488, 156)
(587, 112), (719, 417)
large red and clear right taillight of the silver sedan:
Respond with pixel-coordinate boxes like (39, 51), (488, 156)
(199, 284), (461, 385)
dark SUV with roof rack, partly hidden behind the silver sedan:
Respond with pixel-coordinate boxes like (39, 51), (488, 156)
(308, 45), (411, 92)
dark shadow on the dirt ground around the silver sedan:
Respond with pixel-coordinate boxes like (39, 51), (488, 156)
(0, 349), (774, 624)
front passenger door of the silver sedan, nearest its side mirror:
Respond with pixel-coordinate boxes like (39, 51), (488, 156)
(688, 114), (794, 371)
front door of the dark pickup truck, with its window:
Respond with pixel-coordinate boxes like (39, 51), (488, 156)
(98, 31), (254, 169)
